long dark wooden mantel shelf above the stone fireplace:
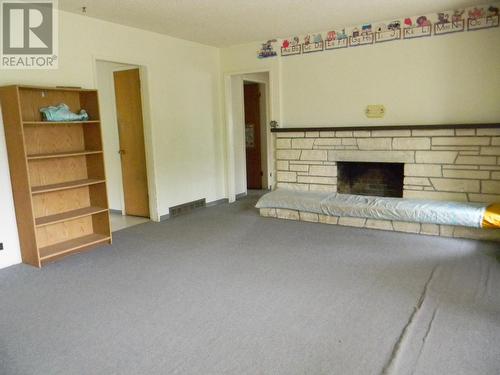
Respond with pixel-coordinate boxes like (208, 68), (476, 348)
(271, 123), (500, 133)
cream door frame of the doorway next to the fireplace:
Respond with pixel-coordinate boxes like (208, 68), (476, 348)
(224, 68), (279, 203)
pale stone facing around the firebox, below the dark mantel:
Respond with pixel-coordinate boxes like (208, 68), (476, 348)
(273, 125), (500, 202)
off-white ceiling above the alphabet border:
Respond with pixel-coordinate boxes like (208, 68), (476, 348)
(59, 0), (485, 47)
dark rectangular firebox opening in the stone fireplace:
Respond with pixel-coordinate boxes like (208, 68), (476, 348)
(337, 161), (404, 198)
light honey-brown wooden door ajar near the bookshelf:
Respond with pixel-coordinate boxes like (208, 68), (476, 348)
(113, 69), (149, 217)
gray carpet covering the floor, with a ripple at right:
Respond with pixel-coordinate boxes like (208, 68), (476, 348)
(0, 196), (500, 375)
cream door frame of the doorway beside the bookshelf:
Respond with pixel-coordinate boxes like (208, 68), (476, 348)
(92, 55), (160, 222)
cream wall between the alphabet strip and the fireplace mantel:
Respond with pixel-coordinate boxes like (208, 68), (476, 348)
(221, 28), (500, 127)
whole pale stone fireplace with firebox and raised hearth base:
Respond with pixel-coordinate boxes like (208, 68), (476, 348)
(270, 124), (500, 240)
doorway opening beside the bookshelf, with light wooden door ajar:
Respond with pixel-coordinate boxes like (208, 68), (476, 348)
(96, 60), (151, 231)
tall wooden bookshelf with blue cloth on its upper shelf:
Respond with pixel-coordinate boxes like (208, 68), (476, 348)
(0, 85), (111, 267)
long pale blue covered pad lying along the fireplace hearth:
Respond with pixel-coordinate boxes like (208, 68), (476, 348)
(256, 189), (500, 228)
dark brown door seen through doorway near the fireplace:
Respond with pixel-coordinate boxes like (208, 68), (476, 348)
(244, 83), (262, 189)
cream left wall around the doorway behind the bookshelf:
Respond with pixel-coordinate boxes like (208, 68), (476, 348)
(0, 12), (226, 268)
